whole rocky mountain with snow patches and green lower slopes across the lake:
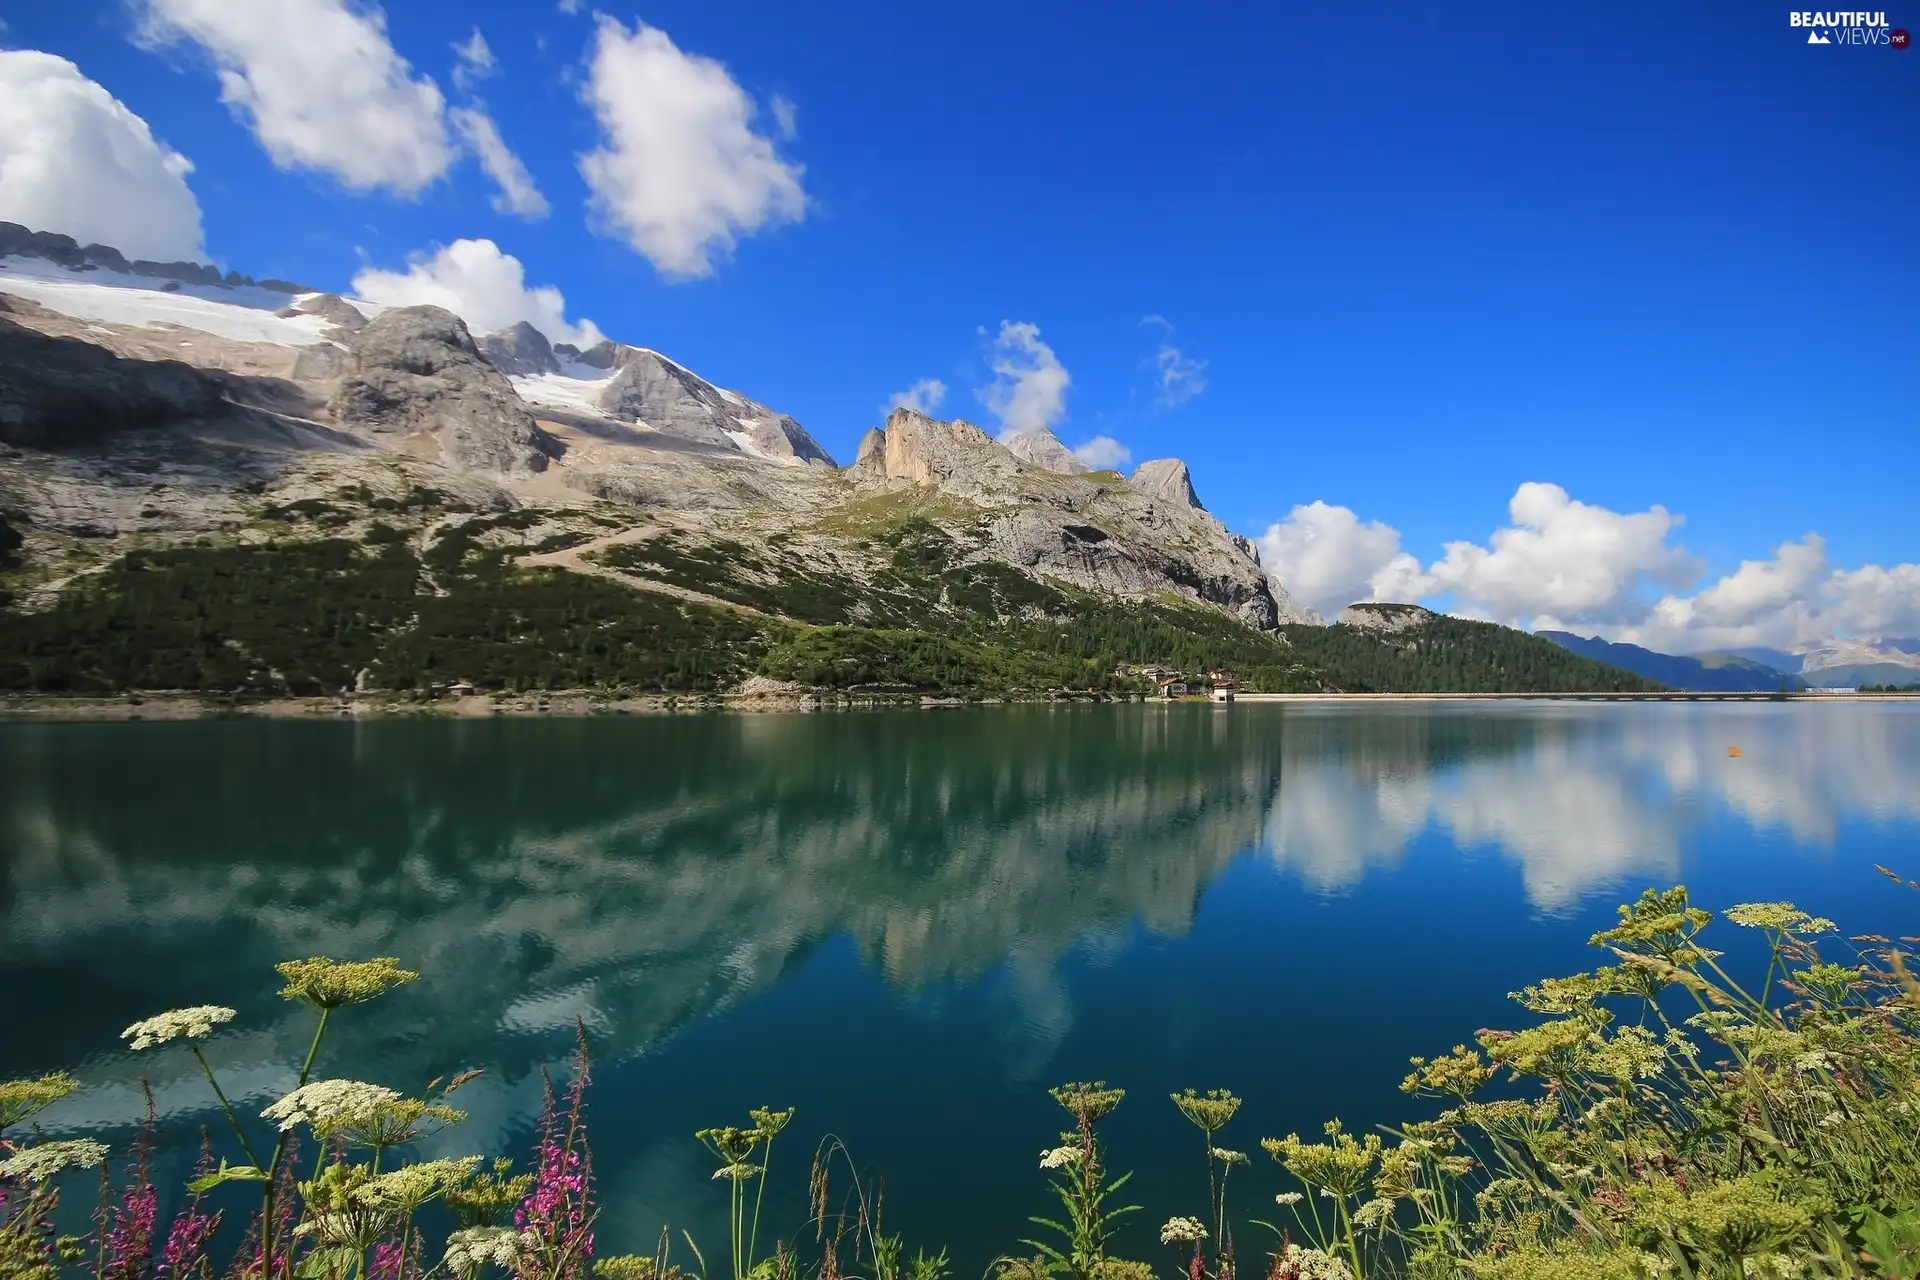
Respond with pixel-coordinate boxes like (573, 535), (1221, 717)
(0, 225), (1697, 695)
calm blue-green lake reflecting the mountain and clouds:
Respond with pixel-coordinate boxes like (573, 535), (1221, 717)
(0, 702), (1920, 1280)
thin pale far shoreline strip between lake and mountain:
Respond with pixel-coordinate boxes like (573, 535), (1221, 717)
(0, 689), (1920, 723)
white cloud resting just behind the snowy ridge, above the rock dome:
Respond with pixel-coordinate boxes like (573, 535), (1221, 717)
(353, 240), (605, 347)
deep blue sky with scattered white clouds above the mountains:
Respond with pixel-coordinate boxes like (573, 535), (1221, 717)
(0, 0), (1920, 649)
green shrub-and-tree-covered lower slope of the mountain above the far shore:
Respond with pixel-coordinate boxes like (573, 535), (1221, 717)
(0, 489), (1649, 697)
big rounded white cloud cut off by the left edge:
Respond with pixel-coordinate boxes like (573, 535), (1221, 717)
(0, 50), (205, 261)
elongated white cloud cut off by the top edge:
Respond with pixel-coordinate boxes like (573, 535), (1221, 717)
(144, 0), (455, 196)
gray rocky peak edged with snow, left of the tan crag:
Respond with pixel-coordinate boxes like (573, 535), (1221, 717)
(580, 342), (835, 466)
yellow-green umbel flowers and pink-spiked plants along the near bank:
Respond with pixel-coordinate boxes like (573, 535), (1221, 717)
(0, 890), (1920, 1280)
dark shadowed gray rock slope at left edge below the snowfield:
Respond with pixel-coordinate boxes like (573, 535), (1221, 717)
(0, 312), (225, 449)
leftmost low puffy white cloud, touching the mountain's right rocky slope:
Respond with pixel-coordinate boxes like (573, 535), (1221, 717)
(1258, 501), (1427, 618)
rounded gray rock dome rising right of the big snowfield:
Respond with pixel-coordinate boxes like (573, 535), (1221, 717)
(332, 307), (559, 474)
